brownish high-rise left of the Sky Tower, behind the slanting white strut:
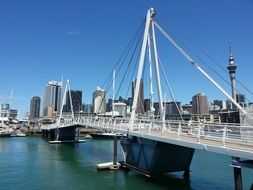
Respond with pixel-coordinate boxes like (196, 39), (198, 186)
(192, 93), (209, 115)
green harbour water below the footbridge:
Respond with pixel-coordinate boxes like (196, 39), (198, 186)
(0, 137), (253, 190)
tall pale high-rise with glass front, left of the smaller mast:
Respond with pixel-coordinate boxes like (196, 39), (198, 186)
(43, 81), (62, 117)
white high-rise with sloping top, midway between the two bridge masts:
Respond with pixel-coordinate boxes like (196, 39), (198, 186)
(92, 87), (106, 114)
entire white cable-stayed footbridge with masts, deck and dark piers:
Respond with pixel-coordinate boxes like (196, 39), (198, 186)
(41, 8), (253, 190)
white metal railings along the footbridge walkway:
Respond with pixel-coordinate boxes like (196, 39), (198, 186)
(42, 116), (253, 151)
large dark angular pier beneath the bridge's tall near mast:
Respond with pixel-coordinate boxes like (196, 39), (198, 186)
(121, 136), (194, 179)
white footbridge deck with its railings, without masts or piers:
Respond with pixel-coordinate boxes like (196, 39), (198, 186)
(41, 116), (253, 160)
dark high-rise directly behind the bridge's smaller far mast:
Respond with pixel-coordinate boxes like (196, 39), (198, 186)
(65, 90), (82, 113)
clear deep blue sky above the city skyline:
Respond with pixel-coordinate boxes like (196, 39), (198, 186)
(0, 0), (253, 116)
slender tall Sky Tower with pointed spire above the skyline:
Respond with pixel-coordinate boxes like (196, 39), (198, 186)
(227, 43), (237, 100)
